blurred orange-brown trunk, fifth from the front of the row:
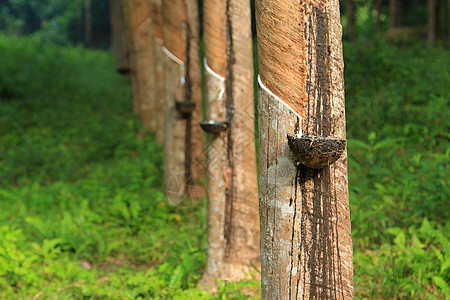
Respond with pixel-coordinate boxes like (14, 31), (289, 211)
(122, 0), (160, 131)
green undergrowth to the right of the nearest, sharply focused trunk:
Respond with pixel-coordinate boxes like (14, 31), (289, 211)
(344, 41), (450, 299)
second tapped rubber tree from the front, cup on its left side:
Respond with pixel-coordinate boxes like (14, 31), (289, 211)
(200, 0), (260, 290)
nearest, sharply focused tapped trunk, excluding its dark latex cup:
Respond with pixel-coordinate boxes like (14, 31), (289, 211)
(256, 0), (354, 299)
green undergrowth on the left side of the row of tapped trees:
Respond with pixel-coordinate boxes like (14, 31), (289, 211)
(0, 36), (255, 299)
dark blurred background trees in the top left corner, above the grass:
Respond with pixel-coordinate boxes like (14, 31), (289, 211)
(0, 0), (110, 48)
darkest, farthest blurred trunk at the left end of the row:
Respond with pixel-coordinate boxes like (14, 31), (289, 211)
(109, 0), (130, 75)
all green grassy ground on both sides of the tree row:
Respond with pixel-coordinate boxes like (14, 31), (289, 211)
(0, 36), (450, 299)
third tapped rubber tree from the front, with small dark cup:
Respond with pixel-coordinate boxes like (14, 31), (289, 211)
(162, 0), (205, 205)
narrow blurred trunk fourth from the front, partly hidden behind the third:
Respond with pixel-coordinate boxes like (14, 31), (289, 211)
(149, 0), (165, 144)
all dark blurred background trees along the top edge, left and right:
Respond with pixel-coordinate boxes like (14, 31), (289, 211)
(0, 0), (450, 48)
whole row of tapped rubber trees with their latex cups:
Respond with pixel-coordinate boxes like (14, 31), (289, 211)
(110, 0), (354, 299)
